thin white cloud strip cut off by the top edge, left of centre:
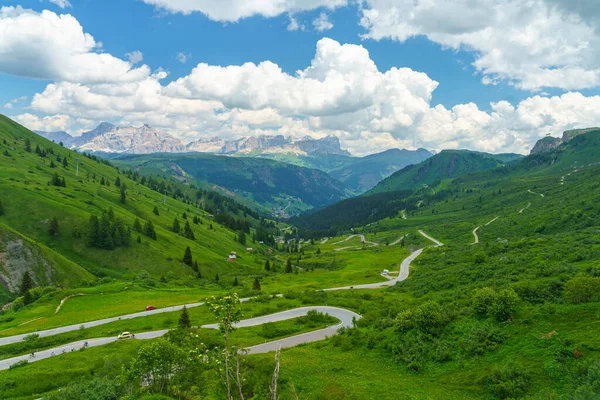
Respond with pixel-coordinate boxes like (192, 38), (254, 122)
(143, 0), (348, 22)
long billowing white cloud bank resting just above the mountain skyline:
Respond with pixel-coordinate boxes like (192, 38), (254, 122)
(15, 27), (600, 155)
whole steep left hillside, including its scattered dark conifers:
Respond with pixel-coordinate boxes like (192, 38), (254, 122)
(0, 116), (276, 300)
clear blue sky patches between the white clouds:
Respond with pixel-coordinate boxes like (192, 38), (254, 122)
(0, 0), (529, 109)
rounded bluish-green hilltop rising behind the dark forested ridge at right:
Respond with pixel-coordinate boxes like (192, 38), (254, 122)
(369, 150), (519, 194)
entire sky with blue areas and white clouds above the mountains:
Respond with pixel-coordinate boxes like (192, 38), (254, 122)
(0, 0), (600, 154)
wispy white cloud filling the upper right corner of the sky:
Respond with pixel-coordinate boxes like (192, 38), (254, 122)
(360, 0), (600, 91)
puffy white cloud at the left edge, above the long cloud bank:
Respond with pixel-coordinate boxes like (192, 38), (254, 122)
(0, 7), (150, 83)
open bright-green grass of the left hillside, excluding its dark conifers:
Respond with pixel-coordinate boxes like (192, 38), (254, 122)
(0, 117), (268, 287)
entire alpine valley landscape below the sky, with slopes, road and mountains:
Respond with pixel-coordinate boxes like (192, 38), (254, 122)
(0, 113), (600, 400)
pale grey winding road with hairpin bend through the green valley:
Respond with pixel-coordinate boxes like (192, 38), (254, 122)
(0, 230), (443, 370)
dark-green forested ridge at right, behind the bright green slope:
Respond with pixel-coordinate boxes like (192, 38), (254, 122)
(298, 130), (600, 237)
